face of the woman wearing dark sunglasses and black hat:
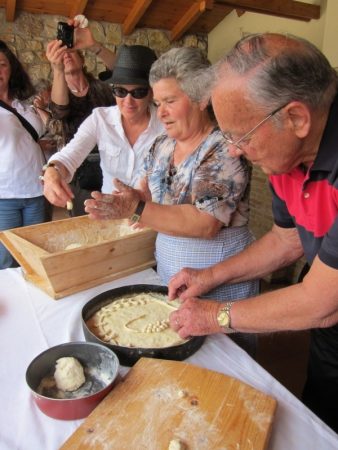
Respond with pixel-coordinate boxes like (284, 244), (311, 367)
(114, 84), (152, 120)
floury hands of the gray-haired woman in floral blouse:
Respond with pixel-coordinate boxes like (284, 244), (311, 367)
(85, 180), (141, 220)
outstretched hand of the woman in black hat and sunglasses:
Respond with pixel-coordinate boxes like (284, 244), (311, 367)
(43, 167), (74, 208)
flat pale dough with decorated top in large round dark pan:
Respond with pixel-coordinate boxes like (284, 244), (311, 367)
(87, 293), (185, 348)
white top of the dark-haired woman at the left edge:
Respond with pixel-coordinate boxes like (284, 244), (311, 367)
(0, 100), (44, 199)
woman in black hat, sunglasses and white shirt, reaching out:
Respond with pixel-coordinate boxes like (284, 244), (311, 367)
(42, 45), (163, 207)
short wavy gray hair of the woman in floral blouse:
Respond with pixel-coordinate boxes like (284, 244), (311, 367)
(149, 47), (210, 103)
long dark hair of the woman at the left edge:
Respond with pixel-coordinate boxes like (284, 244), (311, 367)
(0, 40), (35, 100)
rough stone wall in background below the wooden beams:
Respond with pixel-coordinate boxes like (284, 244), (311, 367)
(0, 8), (208, 81)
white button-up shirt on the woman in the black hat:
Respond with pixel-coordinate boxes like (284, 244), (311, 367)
(50, 106), (164, 194)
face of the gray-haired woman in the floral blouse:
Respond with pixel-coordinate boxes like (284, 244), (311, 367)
(153, 78), (202, 140)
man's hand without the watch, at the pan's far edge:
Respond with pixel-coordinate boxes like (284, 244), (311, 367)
(168, 267), (217, 300)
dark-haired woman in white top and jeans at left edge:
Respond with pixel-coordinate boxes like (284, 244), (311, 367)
(0, 41), (45, 269)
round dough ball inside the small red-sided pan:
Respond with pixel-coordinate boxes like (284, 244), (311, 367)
(54, 356), (86, 391)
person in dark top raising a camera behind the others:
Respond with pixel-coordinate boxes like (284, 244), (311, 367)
(46, 28), (115, 215)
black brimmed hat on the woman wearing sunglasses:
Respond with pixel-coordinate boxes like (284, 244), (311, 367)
(106, 45), (157, 86)
